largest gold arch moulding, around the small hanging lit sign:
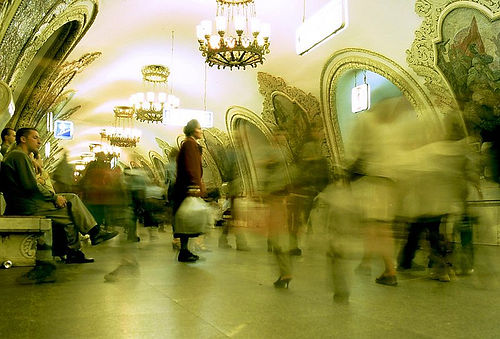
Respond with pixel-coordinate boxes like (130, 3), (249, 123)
(321, 48), (438, 168)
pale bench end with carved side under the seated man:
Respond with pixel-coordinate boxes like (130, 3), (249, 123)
(0, 216), (52, 266)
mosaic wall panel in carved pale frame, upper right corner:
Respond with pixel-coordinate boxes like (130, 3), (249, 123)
(406, 0), (500, 115)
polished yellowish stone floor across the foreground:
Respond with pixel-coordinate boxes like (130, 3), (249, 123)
(0, 229), (500, 339)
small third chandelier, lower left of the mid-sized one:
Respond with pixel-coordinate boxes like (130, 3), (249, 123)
(101, 106), (141, 147)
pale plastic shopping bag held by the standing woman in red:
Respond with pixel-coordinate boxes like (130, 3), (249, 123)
(175, 197), (214, 234)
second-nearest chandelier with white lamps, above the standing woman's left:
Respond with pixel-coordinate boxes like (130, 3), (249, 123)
(130, 65), (179, 123)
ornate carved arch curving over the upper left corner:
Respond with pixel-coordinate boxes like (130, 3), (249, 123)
(0, 0), (98, 126)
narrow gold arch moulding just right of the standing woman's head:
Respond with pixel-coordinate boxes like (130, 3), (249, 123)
(226, 106), (290, 196)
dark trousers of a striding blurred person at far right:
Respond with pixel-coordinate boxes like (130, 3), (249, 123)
(399, 216), (444, 268)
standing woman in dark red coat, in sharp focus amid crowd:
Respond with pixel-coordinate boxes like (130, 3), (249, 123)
(173, 119), (205, 262)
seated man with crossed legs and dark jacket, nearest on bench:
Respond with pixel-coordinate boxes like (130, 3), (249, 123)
(0, 128), (118, 263)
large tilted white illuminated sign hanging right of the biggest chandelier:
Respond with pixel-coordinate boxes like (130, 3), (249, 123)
(295, 0), (347, 55)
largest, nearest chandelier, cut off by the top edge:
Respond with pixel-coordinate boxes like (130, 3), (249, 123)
(196, 0), (271, 70)
